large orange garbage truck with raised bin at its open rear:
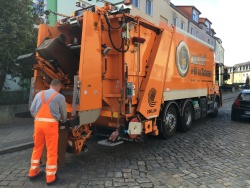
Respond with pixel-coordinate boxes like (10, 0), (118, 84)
(18, 1), (222, 153)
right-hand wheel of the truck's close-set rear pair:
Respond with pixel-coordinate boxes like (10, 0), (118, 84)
(180, 102), (194, 132)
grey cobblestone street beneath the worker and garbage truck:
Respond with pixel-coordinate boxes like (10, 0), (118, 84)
(0, 90), (250, 188)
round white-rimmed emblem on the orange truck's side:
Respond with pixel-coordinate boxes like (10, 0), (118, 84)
(176, 41), (190, 77)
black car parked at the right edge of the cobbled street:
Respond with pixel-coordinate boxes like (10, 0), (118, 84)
(231, 89), (250, 120)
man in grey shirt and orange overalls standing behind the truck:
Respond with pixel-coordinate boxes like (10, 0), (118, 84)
(29, 79), (67, 185)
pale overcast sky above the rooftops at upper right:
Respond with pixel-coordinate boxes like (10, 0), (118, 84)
(171, 0), (250, 66)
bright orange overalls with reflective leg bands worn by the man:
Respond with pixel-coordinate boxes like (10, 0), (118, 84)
(29, 91), (59, 183)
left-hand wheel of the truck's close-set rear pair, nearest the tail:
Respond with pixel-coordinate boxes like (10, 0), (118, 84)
(162, 105), (177, 139)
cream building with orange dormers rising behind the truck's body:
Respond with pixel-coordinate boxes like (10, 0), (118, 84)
(131, 0), (224, 69)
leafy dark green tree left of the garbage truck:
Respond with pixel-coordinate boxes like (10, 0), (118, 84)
(0, 0), (39, 91)
